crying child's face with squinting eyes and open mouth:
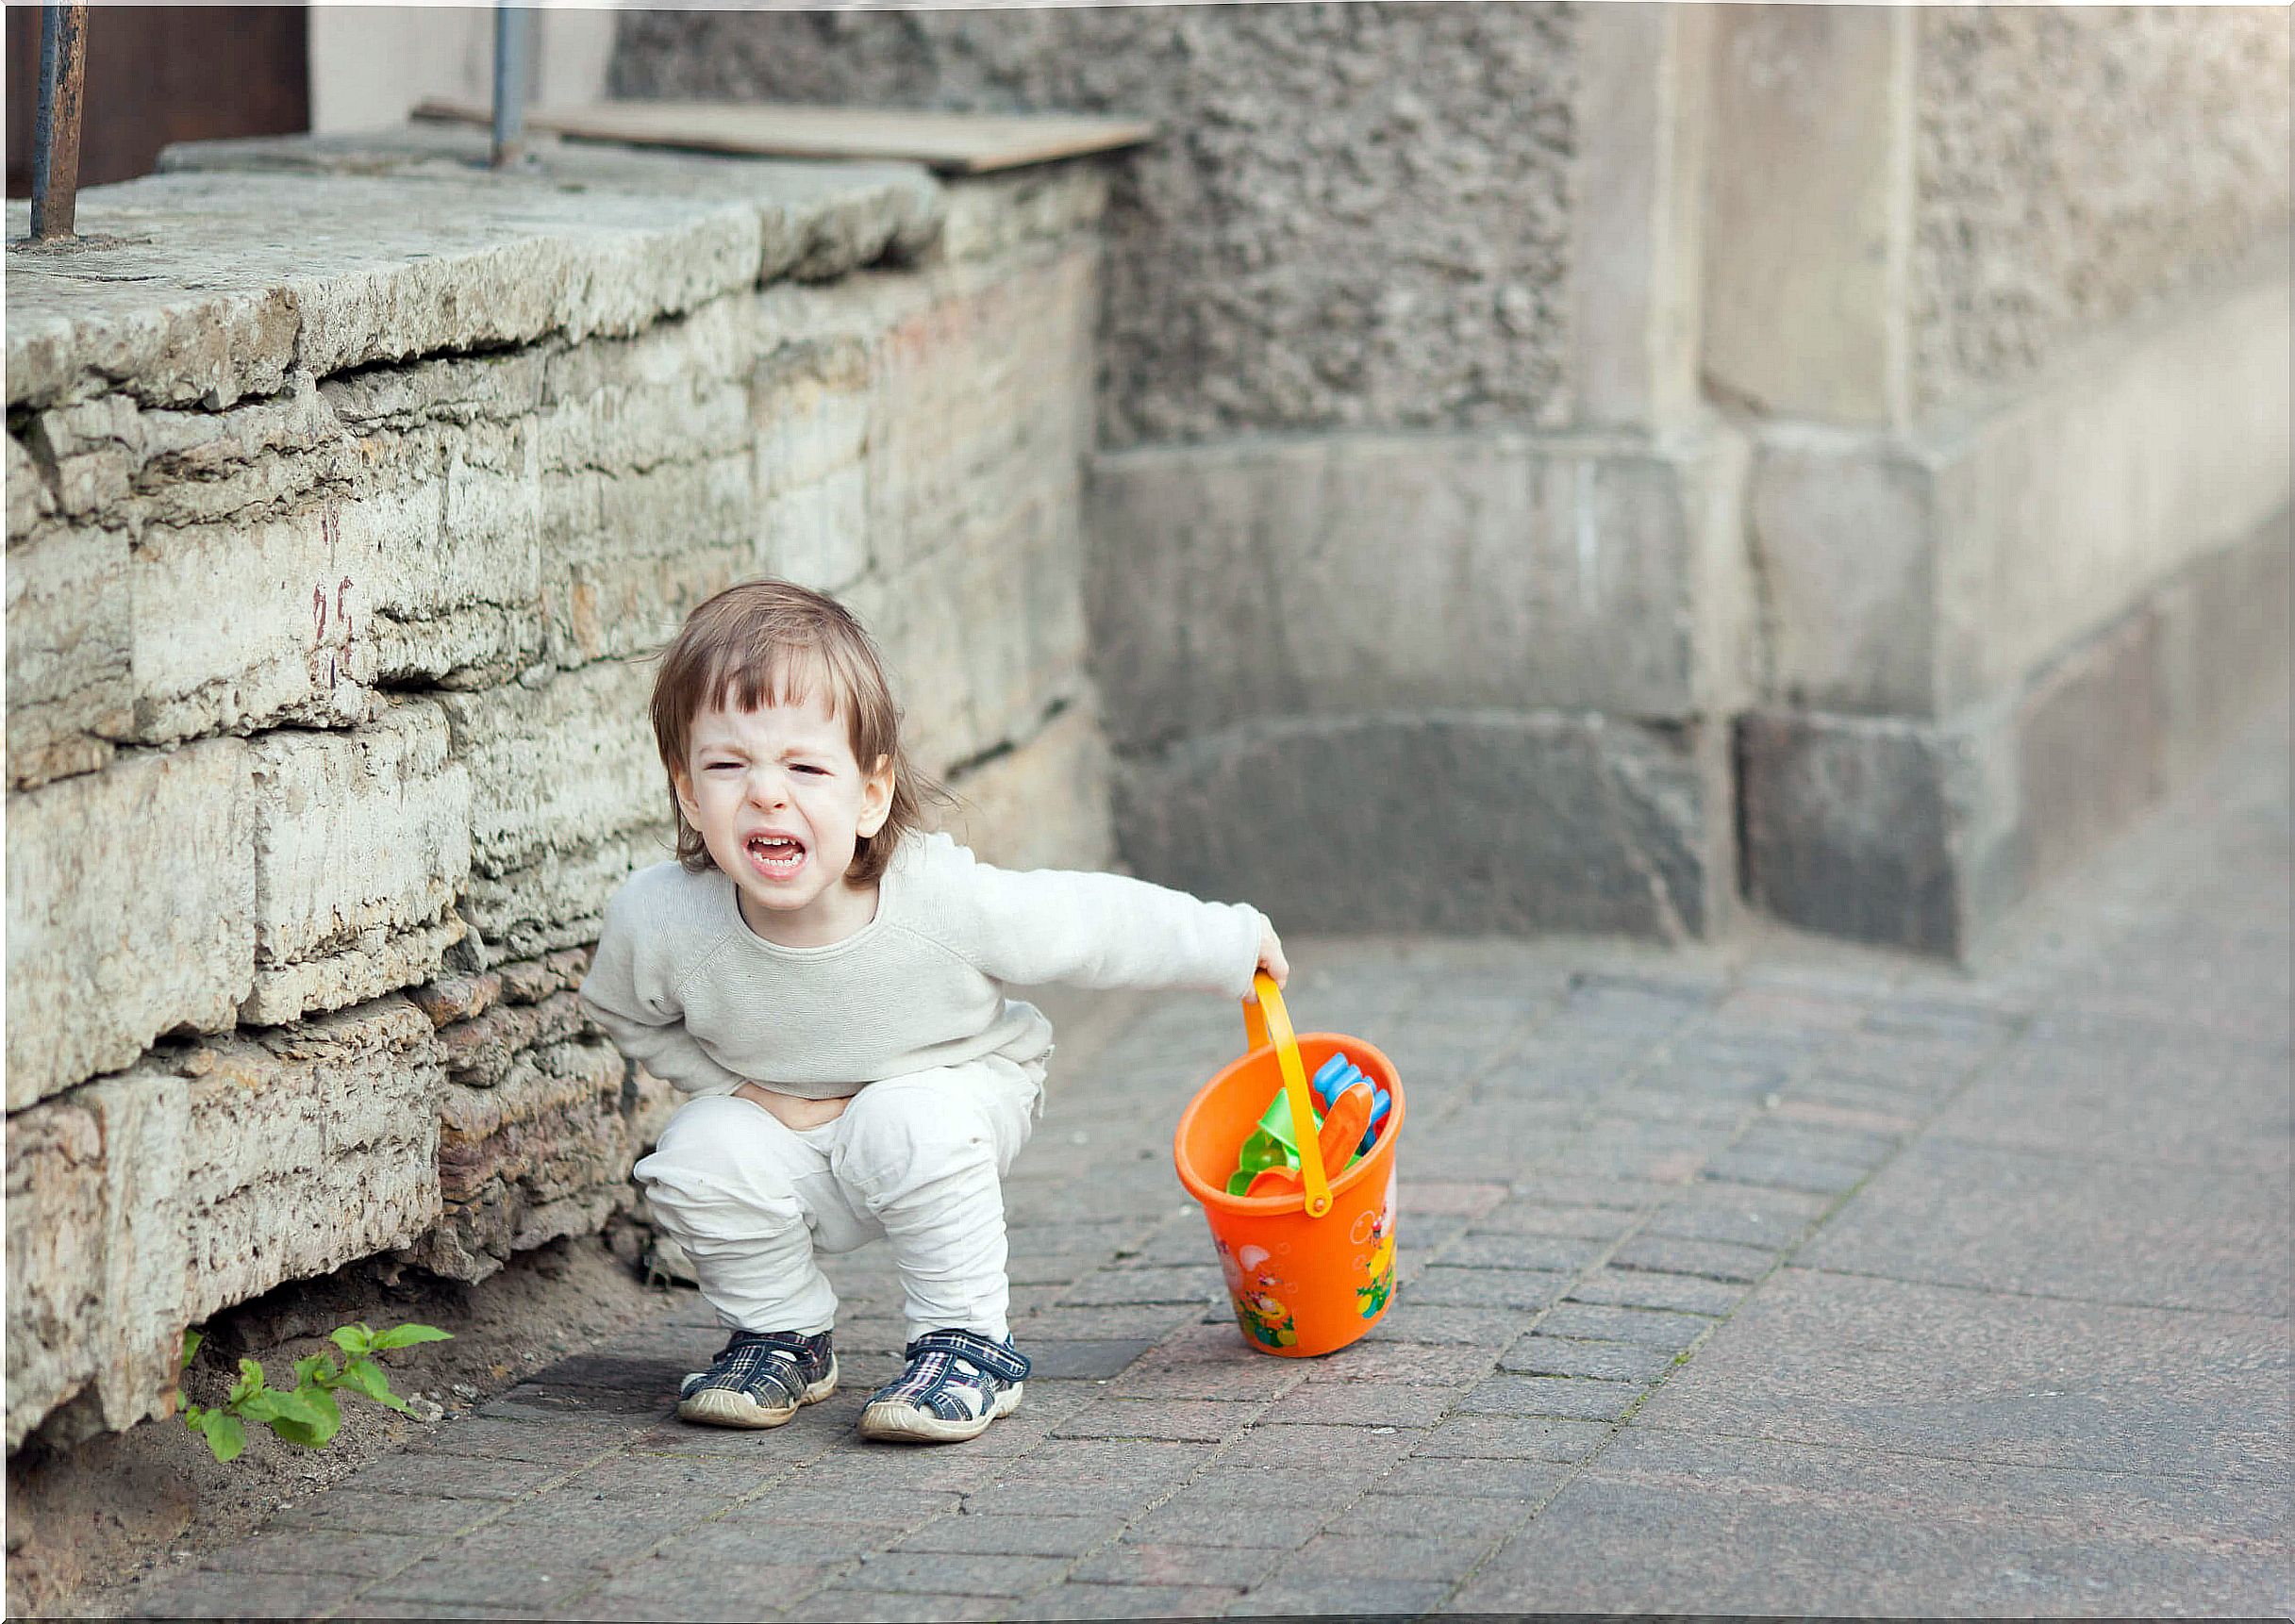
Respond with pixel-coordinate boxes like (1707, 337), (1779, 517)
(677, 684), (892, 948)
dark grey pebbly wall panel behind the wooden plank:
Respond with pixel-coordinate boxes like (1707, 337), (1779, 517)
(613, 5), (1579, 445)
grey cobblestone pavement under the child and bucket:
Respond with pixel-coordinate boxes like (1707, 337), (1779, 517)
(144, 716), (2295, 1619)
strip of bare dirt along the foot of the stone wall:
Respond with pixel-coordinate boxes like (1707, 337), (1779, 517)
(7, 1225), (686, 1617)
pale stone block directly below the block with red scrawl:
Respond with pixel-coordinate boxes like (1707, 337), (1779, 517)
(241, 700), (471, 1025)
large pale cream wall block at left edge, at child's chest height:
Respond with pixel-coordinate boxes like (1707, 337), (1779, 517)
(7, 738), (255, 1110)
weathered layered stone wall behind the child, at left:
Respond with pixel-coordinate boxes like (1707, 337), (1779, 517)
(7, 131), (1111, 1448)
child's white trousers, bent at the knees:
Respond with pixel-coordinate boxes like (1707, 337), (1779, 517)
(636, 1055), (1044, 1339)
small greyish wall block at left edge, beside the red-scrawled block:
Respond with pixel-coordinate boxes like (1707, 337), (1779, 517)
(7, 522), (136, 789)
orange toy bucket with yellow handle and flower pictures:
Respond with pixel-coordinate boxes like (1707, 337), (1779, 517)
(1171, 975), (1403, 1358)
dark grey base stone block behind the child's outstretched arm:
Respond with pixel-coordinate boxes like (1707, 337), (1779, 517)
(1115, 711), (1735, 940)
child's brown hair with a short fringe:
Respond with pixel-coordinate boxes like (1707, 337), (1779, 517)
(652, 580), (945, 886)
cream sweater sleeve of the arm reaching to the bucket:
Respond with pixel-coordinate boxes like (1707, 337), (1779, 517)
(934, 842), (1265, 998)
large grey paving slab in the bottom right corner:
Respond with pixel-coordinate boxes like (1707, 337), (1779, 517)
(1451, 1429), (2290, 1617)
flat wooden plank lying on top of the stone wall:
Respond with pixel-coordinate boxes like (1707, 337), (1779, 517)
(415, 99), (1155, 174)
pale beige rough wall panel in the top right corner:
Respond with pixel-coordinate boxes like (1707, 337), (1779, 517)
(1912, 7), (2290, 402)
